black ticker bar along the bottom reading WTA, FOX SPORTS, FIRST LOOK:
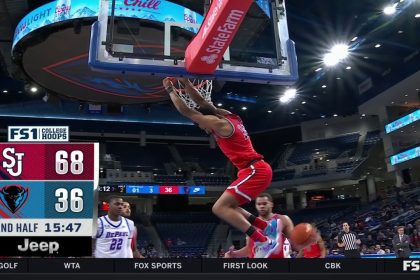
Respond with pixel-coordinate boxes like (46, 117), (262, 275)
(0, 258), (420, 274)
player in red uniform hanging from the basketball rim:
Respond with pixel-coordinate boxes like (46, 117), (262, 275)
(163, 78), (277, 258)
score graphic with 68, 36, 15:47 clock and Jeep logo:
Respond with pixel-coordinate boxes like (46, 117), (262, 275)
(0, 143), (99, 257)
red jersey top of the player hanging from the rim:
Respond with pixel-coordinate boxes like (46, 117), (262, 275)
(213, 114), (263, 169)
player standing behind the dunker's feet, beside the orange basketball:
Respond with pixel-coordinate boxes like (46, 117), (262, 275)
(224, 193), (294, 259)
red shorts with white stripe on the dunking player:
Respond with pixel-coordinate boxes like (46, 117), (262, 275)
(225, 160), (273, 205)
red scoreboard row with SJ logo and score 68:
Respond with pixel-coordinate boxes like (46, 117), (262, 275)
(0, 143), (95, 180)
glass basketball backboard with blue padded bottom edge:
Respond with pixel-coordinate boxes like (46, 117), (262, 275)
(89, 0), (298, 85)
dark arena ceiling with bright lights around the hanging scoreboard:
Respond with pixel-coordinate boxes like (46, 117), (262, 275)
(0, 0), (420, 131)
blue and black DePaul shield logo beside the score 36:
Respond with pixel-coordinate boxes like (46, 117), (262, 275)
(0, 185), (29, 214)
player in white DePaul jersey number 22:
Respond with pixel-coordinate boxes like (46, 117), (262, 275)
(93, 196), (143, 258)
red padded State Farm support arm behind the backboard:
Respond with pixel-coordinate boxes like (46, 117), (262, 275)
(185, 0), (253, 74)
